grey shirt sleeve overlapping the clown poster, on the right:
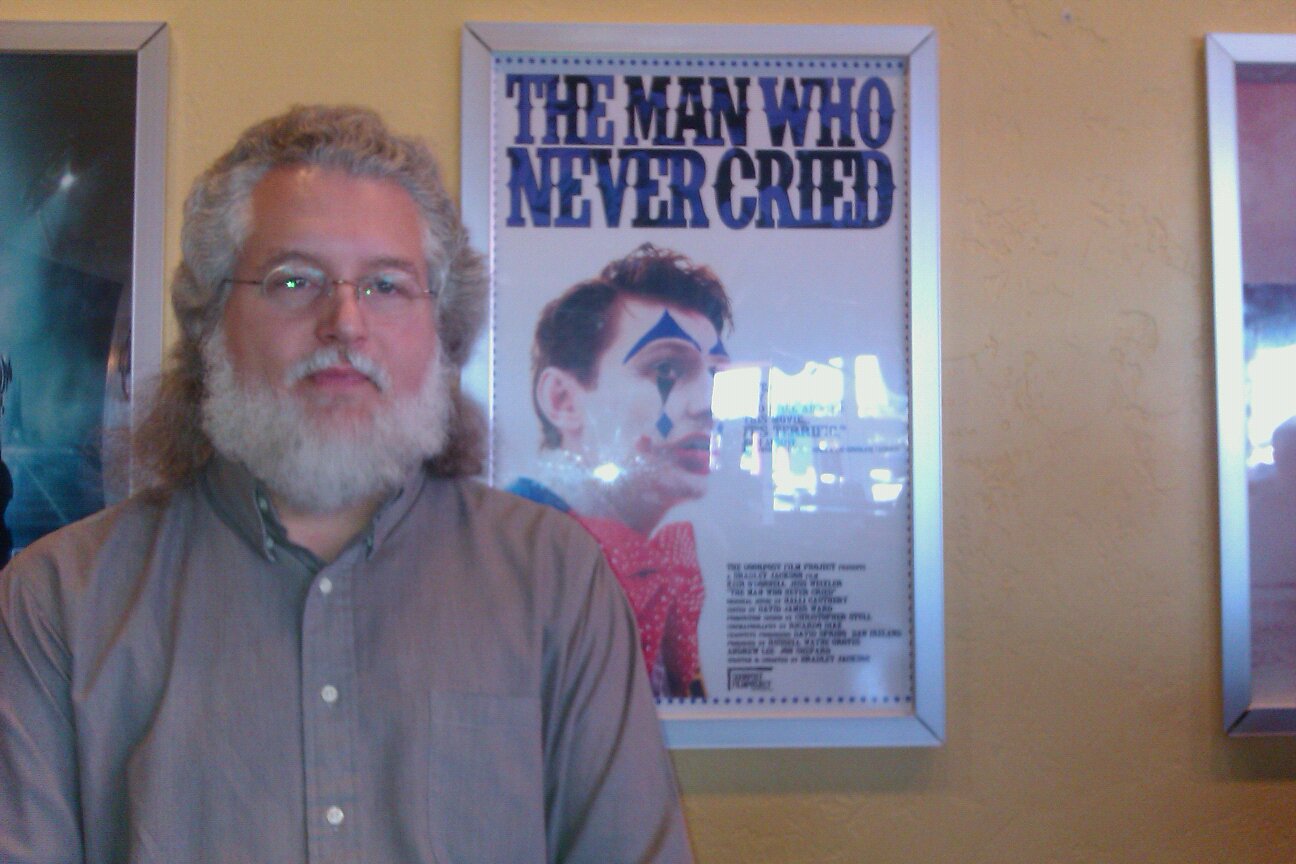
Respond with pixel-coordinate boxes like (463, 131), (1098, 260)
(546, 544), (692, 864)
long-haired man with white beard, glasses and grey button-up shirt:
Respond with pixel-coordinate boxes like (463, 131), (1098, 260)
(0, 108), (689, 864)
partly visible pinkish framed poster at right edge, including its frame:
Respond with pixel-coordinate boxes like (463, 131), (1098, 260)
(1207, 34), (1296, 734)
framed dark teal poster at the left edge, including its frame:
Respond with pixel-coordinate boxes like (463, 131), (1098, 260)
(0, 21), (167, 565)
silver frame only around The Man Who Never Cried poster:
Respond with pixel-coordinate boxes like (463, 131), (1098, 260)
(460, 22), (945, 747)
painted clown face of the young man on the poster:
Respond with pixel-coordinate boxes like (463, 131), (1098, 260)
(564, 298), (727, 501)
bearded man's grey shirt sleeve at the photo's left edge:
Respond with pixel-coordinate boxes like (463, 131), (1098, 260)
(0, 554), (83, 864)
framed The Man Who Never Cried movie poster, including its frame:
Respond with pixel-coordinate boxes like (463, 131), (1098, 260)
(463, 23), (945, 747)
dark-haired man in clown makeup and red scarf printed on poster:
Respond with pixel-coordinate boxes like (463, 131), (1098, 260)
(509, 244), (731, 698)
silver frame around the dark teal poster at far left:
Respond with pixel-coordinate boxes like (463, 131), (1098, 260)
(0, 21), (168, 491)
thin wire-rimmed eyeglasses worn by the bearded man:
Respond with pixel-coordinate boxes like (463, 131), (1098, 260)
(226, 264), (437, 317)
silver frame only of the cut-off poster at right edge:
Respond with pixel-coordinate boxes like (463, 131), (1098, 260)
(1205, 34), (1296, 736)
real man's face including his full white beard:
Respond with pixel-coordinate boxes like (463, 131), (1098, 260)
(202, 167), (454, 512)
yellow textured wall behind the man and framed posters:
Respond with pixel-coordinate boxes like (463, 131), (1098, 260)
(0, 0), (1296, 864)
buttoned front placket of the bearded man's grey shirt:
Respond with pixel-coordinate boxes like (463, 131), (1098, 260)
(302, 556), (360, 864)
